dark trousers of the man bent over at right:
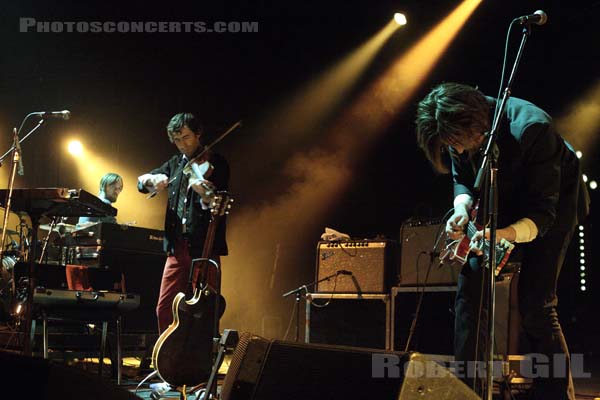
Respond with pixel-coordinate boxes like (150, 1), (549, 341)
(454, 229), (575, 400)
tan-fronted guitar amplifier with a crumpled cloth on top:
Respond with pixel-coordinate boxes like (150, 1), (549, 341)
(316, 240), (397, 293)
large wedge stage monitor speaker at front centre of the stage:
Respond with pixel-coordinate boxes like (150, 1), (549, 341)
(221, 333), (478, 400)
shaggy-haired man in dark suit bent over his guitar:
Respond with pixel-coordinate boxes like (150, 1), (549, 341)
(416, 83), (588, 399)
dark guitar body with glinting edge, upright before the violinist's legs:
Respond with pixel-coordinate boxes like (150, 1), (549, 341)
(152, 287), (225, 387)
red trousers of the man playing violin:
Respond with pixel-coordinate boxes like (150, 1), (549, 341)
(156, 240), (221, 333)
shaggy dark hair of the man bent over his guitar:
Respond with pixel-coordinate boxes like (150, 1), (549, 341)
(415, 83), (490, 173)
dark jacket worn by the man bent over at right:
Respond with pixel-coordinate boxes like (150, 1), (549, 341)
(451, 98), (587, 237)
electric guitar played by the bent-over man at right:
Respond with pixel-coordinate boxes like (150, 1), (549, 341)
(440, 208), (515, 276)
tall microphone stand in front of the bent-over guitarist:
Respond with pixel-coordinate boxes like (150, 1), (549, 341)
(474, 24), (531, 400)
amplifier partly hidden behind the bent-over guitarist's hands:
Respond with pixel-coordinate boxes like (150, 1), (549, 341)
(398, 220), (462, 286)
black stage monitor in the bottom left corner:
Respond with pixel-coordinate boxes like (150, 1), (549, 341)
(0, 351), (139, 400)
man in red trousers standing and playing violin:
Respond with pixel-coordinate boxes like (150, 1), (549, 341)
(138, 113), (229, 333)
